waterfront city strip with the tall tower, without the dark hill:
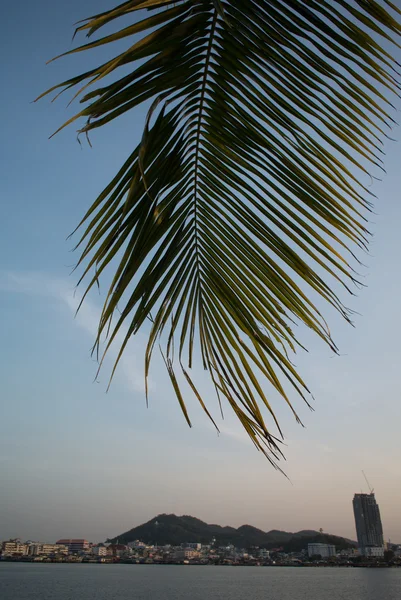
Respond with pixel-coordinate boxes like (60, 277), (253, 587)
(0, 491), (401, 567)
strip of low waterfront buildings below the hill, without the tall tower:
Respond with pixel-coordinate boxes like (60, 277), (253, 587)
(5, 539), (401, 567)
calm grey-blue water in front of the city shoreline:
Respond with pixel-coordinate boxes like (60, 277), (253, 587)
(0, 563), (401, 600)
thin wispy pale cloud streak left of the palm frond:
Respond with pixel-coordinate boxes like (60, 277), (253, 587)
(0, 271), (144, 392)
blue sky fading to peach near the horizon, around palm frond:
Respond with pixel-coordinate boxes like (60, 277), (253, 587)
(0, 0), (401, 543)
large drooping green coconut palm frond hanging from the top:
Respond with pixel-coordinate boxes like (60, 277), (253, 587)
(39, 0), (401, 464)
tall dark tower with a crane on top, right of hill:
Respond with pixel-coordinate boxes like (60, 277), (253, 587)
(352, 493), (384, 556)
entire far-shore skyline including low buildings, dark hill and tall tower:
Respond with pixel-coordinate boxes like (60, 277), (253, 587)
(0, 508), (401, 566)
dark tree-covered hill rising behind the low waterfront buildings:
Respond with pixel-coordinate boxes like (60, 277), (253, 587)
(108, 514), (356, 552)
